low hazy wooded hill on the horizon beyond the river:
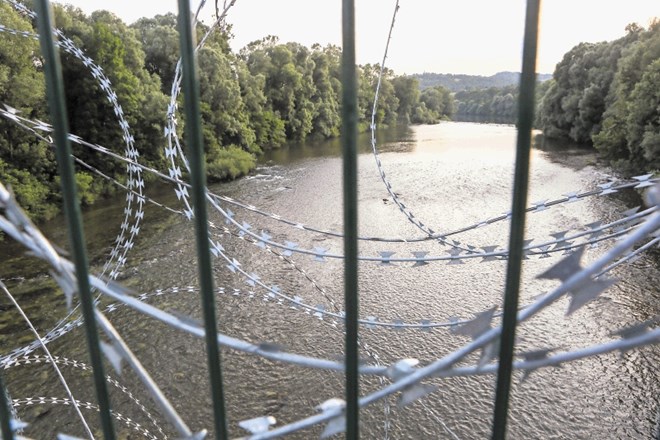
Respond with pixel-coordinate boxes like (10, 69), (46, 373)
(411, 72), (552, 92)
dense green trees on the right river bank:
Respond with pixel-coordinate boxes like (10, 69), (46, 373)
(538, 21), (660, 174)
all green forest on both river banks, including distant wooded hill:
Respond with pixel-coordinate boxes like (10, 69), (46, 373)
(0, 3), (660, 220)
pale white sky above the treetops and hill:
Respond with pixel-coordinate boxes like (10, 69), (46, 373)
(52, 0), (660, 75)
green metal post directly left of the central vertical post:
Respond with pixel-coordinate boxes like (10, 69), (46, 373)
(179, 0), (228, 439)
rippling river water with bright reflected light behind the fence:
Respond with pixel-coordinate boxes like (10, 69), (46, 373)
(0, 122), (660, 439)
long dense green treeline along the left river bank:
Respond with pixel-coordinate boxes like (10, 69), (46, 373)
(0, 3), (453, 219)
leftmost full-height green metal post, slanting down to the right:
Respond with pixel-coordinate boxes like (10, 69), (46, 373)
(35, 0), (115, 439)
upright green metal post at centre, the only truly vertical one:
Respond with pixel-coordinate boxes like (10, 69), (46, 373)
(341, 0), (360, 440)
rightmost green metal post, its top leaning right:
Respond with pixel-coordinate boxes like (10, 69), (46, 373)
(492, 0), (540, 440)
